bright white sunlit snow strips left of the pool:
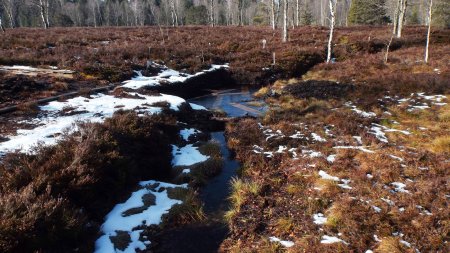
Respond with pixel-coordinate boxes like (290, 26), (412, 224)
(0, 65), (224, 155)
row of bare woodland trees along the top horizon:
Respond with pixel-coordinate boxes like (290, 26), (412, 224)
(0, 0), (450, 28)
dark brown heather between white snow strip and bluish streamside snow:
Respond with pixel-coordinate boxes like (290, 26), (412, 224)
(0, 112), (178, 252)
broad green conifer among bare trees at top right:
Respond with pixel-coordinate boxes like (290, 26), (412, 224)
(348, 0), (389, 25)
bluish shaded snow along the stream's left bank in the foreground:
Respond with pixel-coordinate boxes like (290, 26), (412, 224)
(95, 125), (209, 253)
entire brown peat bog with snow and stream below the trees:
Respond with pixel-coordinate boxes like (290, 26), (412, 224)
(0, 26), (450, 252)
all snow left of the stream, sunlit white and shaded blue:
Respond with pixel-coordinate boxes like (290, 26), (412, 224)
(0, 65), (224, 253)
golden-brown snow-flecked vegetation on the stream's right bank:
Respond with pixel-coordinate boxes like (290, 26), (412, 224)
(222, 82), (449, 253)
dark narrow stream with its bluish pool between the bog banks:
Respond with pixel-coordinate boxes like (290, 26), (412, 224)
(154, 90), (266, 253)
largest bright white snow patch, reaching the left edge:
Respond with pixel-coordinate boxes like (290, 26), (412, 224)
(0, 93), (185, 153)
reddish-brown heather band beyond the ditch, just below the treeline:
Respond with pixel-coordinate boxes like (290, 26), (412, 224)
(0, 27), (442, 83)
